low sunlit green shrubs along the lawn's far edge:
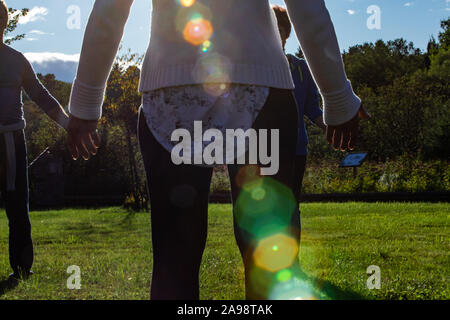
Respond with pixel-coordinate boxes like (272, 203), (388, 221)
(211, 155), (450, 194)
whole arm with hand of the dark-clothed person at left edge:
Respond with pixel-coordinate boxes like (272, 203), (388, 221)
(22, 57), (69, 129)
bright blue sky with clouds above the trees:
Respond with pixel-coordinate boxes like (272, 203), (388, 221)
(6, 0), (450, 81)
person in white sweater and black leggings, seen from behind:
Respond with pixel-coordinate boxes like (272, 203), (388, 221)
(68, 0), (366, 299)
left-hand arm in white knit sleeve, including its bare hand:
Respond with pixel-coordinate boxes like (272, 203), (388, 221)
(67, 0), (133, 159)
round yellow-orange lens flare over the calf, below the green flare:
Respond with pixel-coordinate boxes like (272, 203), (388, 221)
(253, 234), (298, 272)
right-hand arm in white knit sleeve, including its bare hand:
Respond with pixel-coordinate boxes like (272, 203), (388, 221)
(284, 0), (370, 150)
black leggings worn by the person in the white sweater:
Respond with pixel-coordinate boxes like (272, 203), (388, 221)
(138, 89), (300, 300)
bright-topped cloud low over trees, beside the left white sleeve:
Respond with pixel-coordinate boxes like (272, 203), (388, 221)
(24, 52), (80, 82)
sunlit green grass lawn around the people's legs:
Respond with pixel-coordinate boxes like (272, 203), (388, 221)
(0, 203), (450, 299)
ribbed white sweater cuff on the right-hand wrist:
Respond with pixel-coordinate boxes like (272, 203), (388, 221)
(321, 80), (361, 126)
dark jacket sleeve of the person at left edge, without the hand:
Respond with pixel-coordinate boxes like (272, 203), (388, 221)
(22, 57), (59, 113)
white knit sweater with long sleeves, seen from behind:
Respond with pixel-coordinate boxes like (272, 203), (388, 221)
(70, 0), (361, 125)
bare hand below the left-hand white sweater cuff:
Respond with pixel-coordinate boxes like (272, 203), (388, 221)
(67, 115), (100, 160)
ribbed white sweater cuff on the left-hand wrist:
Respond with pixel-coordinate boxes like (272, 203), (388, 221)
(69, 79), (106, 120)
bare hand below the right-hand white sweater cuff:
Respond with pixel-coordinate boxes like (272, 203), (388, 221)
(326, 105), (371, 151)
